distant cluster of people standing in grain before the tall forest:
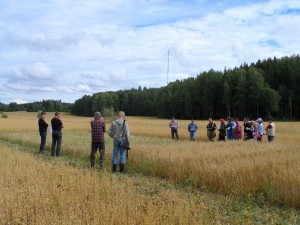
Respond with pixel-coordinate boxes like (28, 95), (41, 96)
(169, 117), (275, 142)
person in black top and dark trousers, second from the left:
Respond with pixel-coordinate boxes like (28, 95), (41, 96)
(51, 112), (64, 157)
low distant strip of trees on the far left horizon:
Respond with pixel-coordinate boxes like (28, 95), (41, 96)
(0, 100), (73, 112)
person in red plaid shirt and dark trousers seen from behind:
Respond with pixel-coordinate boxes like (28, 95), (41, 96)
(90, 112), (106, 169)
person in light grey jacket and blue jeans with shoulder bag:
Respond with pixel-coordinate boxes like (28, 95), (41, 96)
(108, 111), (130, 173)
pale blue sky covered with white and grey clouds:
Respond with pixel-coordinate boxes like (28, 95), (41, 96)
(0, 0), (300, 104)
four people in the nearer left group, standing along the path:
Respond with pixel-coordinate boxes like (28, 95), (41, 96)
(38, 111), (130, 173)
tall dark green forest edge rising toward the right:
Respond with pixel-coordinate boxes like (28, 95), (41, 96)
(71, 55), (300, 120)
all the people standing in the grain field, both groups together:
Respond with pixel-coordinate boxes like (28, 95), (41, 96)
(38, 111), (275, 173)
